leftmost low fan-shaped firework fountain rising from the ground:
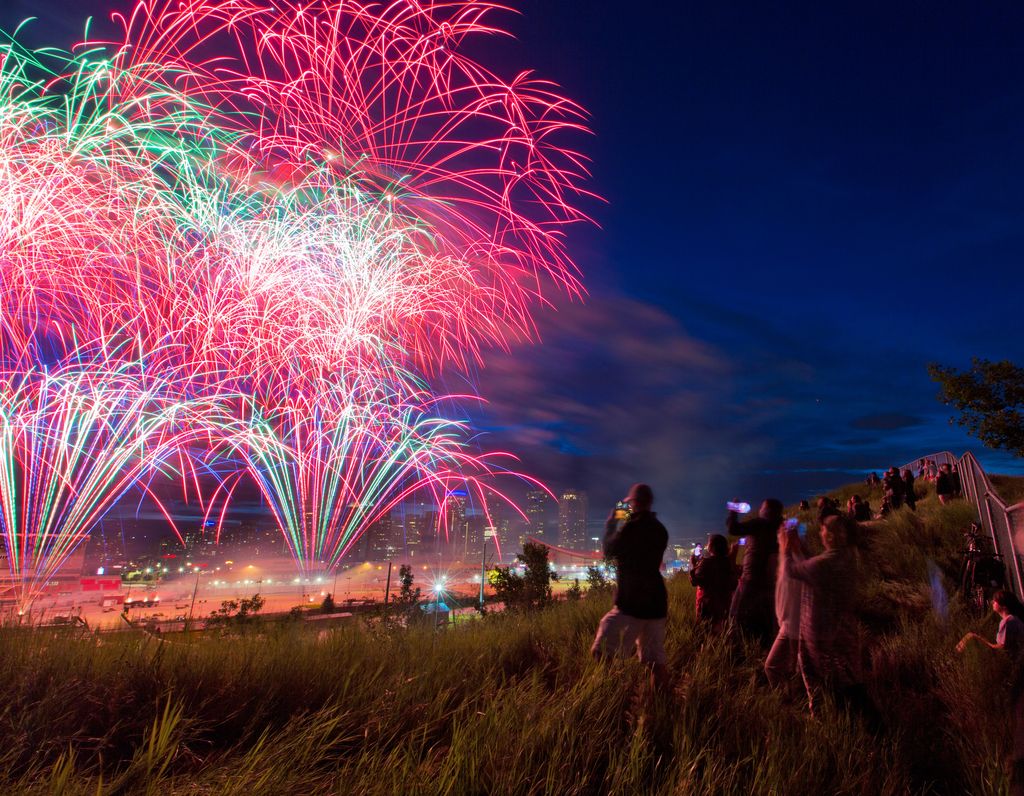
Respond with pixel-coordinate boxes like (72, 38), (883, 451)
(0, 363), (202, 611)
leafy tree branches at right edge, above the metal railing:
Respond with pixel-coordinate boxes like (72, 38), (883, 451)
(928, 359), (1024, 456)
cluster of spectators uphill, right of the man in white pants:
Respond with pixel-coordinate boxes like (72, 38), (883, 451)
(689, 459), (966, 716)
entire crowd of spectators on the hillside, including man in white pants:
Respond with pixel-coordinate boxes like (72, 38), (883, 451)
(592, 460), (970, 721)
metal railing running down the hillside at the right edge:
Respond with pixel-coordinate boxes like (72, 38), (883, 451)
(905, 451), (1024, 600)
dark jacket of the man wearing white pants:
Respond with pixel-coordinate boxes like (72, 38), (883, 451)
(604, 511), (669, 619)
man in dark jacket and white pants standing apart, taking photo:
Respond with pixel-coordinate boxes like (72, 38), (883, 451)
(590, 484), (669, 688)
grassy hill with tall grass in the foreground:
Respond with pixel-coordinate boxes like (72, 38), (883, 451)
(0, 477), (1010, 796)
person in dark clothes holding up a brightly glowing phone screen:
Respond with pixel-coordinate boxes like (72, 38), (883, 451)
(726, 498), (782, 647)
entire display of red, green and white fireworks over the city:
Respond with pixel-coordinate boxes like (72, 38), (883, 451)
(0, 0), (590, 593)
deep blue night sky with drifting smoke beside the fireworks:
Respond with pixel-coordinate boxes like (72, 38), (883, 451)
(6, 0), (1024, 538)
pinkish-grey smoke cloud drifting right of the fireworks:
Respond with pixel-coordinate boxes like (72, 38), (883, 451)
(442, 297), (765, 536)
